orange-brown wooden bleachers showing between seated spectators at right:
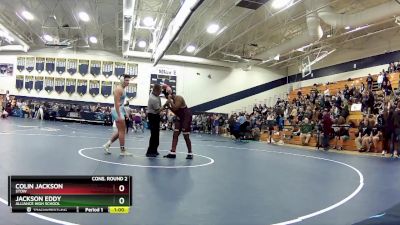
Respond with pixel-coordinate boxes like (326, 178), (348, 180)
(260, 73), (400, 152)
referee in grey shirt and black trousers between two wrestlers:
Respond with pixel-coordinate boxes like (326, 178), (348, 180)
(146, 84), (163, 157)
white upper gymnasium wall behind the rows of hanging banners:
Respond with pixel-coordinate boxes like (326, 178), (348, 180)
(0, 48), (286, 113)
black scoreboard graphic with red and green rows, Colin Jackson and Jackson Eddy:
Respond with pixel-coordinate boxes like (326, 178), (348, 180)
(8, 175), (132, 213)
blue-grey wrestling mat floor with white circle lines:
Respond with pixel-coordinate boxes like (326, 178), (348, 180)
(0, 118), (400, 225)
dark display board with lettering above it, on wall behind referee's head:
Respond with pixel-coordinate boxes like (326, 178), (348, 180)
(150, 67), (177, 93)
